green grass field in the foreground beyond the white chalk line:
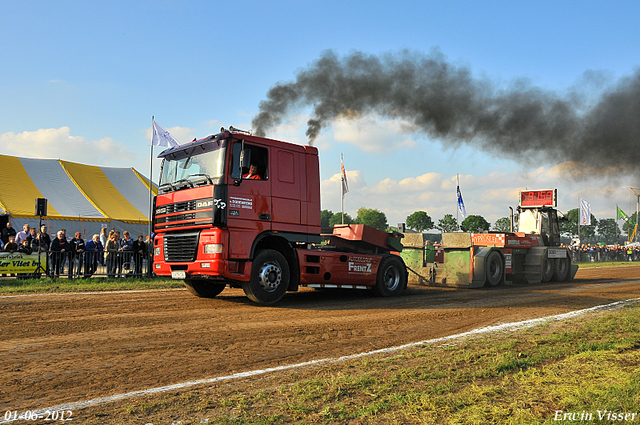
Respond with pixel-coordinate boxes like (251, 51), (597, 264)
(80, 306), (640, 424)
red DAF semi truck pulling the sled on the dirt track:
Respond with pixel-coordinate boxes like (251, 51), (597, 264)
(153, 127), (407, 304)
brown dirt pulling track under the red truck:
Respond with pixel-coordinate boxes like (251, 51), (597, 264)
(0, 266), (640, 412)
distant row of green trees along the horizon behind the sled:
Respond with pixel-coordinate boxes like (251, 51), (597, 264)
(321, 207), (637, 243)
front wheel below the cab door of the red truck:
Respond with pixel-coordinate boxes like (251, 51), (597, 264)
(242, 249), (290, 304)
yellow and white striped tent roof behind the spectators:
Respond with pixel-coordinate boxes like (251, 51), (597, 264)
(0, 155), (157, 238)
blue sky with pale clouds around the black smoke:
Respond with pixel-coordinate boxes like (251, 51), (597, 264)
(0, 0), (640, 229)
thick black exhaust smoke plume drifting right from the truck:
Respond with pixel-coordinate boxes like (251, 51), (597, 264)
(252, 50), (640, 175)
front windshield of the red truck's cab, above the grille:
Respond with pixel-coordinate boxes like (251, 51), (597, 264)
(159, 140), (227, 193)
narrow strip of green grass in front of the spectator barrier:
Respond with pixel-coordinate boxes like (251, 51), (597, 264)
(0, 277), (184, 295)
